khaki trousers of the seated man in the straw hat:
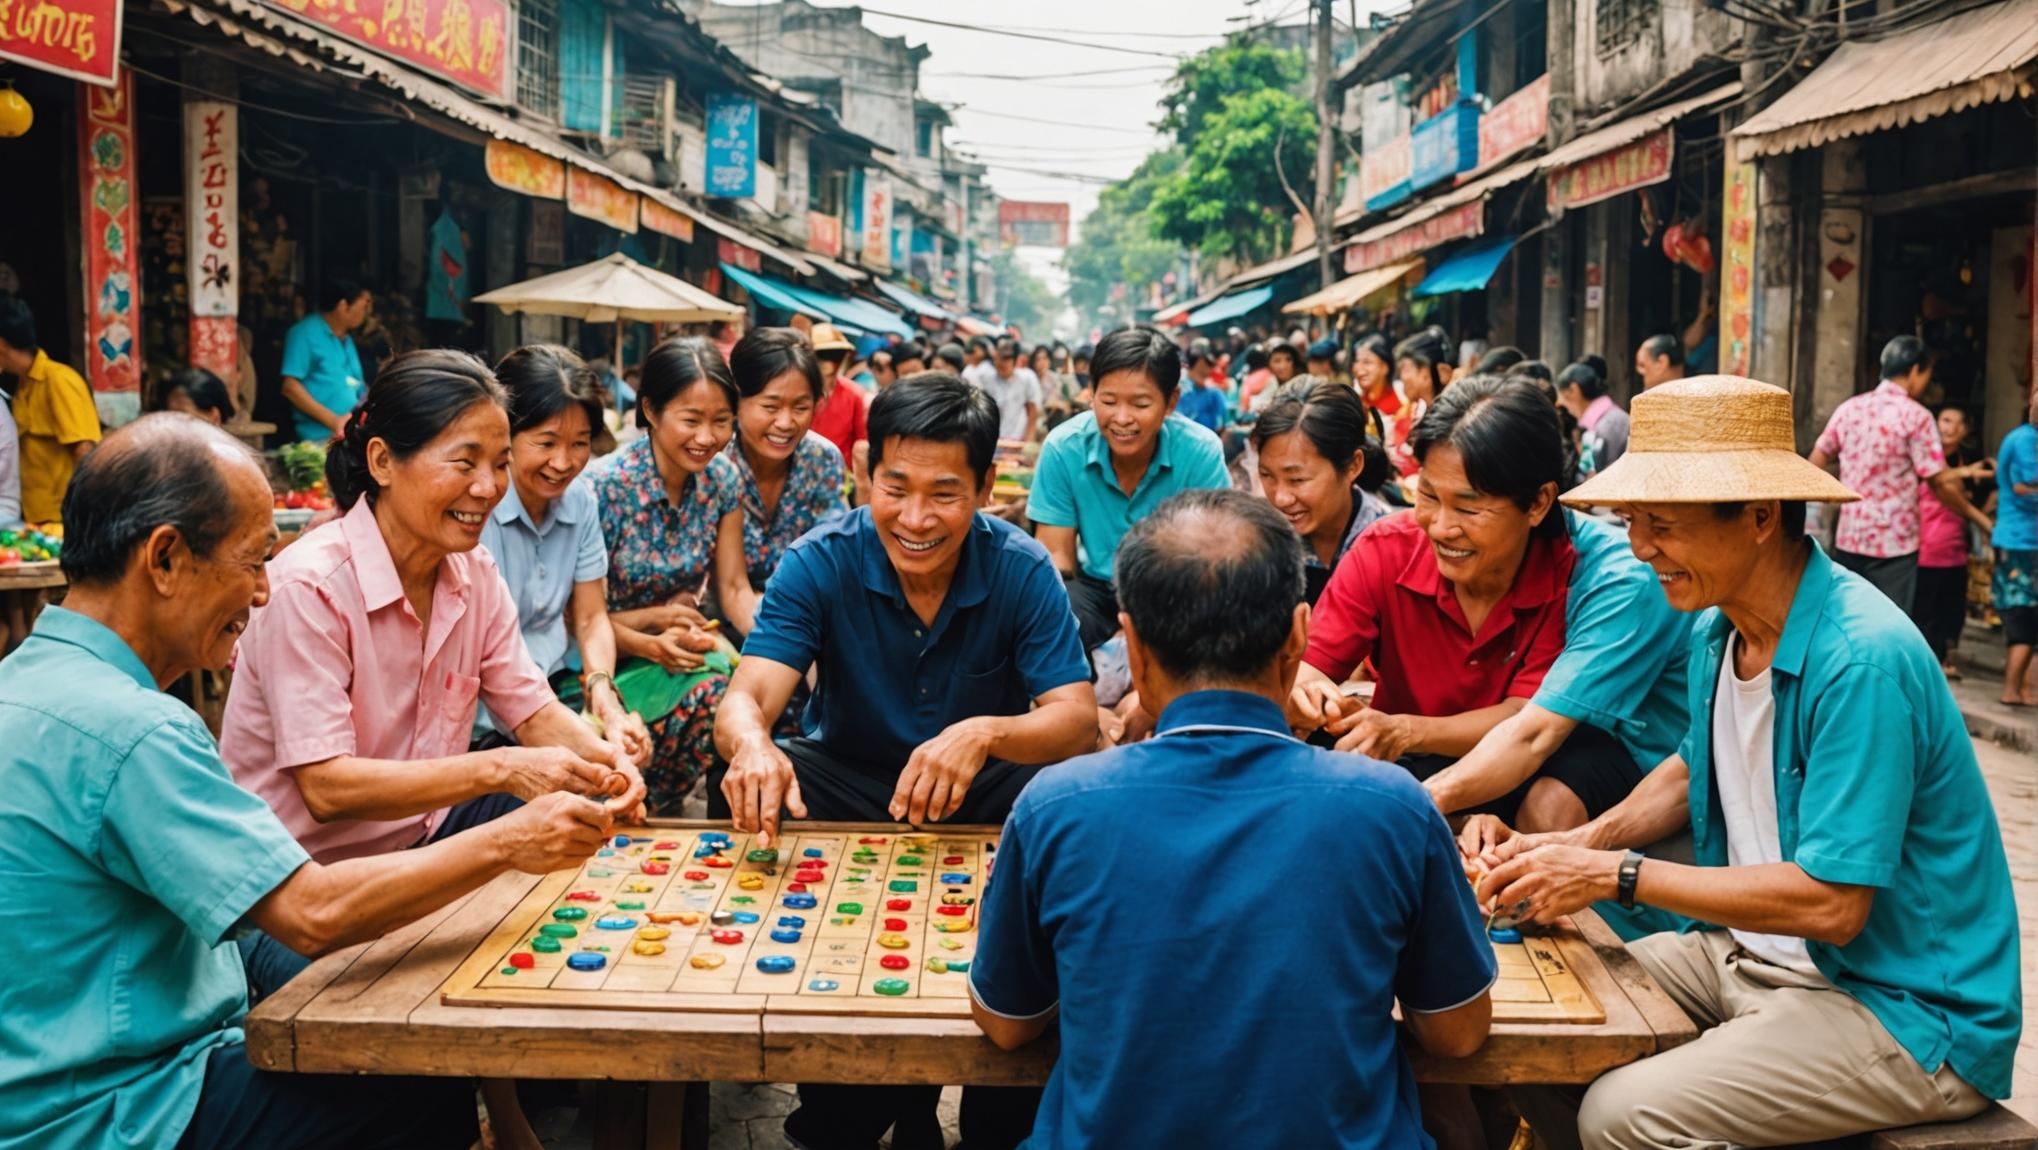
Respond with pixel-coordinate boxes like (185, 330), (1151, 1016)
(1577, 930), (1989, 1150)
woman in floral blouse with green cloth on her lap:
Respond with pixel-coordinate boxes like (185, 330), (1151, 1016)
(587, 336), (758, 814)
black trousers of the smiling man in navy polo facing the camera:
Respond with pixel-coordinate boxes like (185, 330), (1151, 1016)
(707, 738), (1039, 1150)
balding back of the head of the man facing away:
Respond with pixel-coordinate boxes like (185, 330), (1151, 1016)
(1115, 489), (1304, 685)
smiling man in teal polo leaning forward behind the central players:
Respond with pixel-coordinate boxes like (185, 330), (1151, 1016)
(1025, 328), (1231, 652)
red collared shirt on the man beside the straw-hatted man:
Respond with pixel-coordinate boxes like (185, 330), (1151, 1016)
(1302, 512), (1577, 718)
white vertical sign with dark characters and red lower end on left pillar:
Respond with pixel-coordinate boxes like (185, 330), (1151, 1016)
(183, 100), (240, 379)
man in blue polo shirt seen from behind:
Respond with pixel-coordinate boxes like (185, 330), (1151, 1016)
(970, 491), (1498, 1148)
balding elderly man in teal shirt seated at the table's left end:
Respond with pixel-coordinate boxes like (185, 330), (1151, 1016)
(0, 414), (609, 1150)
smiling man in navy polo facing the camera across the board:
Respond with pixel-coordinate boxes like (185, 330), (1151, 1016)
(707, 371), (1100, 1150)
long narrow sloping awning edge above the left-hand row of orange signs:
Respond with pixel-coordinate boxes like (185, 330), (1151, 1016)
(161, 0), (813, 275)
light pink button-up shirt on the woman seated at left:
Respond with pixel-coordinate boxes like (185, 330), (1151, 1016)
(220, 495), (554, 863)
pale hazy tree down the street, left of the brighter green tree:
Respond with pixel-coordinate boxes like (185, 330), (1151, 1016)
(1062, 149), (1182, 326)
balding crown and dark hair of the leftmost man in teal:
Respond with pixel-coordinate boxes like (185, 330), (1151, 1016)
(63, 412), (269, 587)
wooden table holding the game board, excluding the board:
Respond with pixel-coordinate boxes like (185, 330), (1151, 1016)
(247, 820), (1696, 1146)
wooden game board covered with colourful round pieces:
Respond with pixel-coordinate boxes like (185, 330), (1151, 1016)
(442, 828), (1606, 1024)
